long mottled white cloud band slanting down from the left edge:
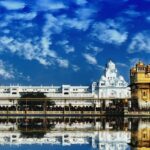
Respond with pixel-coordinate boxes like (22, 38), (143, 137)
(0, 36), (69, 68)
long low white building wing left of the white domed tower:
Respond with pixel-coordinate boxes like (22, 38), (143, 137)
(0, 85), (94, 98)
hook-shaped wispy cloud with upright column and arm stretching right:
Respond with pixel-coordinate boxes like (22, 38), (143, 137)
(43, 14), (92, 44)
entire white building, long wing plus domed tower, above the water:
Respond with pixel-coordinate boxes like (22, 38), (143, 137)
(0, 61), (130, 106)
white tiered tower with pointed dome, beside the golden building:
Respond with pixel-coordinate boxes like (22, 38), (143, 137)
(97, 61), (131, 99)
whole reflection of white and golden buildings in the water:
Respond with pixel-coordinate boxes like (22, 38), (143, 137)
(0, 117), (150, 150)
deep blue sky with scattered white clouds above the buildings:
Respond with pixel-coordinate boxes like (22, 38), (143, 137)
(0, 0), (150, 85)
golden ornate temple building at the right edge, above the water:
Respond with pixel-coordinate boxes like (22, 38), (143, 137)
(130, 61), (150, 108)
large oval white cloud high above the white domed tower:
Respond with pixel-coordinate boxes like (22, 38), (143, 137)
(92, 20), (128, 45)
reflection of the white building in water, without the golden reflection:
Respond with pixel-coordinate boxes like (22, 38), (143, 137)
(0, 122), (131, 150)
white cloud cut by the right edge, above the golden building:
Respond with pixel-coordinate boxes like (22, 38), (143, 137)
(128, 31), (150, 53)
